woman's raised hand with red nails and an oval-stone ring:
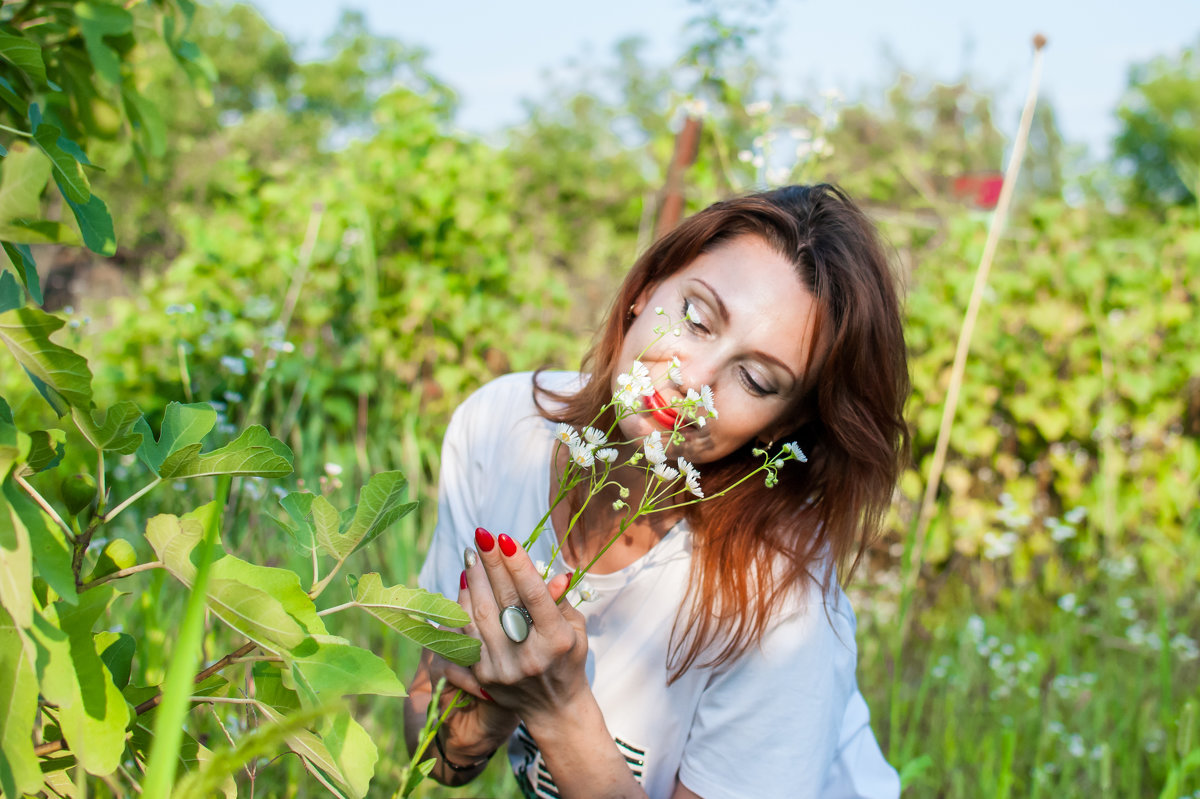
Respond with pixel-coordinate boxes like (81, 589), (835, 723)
(463, 528), (590, 727)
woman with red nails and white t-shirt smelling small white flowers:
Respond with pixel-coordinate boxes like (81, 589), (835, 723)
(406, 185), (908, 799)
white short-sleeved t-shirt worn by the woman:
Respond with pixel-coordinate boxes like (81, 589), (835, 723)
(420, 372), (900, 799)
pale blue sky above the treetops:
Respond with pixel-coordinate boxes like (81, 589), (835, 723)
(253, 0), (1200, 157)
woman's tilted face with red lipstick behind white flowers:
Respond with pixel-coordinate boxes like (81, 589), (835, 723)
(612, 235), (816, 463)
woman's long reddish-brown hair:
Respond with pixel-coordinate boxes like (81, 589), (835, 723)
(535, 184), (910, 679)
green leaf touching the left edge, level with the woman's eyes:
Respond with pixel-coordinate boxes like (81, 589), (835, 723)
(0, 308), (91, 416)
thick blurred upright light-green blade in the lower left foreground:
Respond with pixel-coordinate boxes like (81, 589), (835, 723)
(142, 475), (232, 799)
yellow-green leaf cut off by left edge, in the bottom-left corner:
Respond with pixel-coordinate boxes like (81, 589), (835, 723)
(0, 608), (42, 797)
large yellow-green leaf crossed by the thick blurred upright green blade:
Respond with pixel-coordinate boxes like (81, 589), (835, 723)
(146, 513), (328, 654)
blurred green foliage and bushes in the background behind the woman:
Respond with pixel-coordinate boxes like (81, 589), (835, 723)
(0, 4), (1200, 795)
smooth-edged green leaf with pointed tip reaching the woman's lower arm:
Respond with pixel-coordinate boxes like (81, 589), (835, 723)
(283, 636), (406, 699)
